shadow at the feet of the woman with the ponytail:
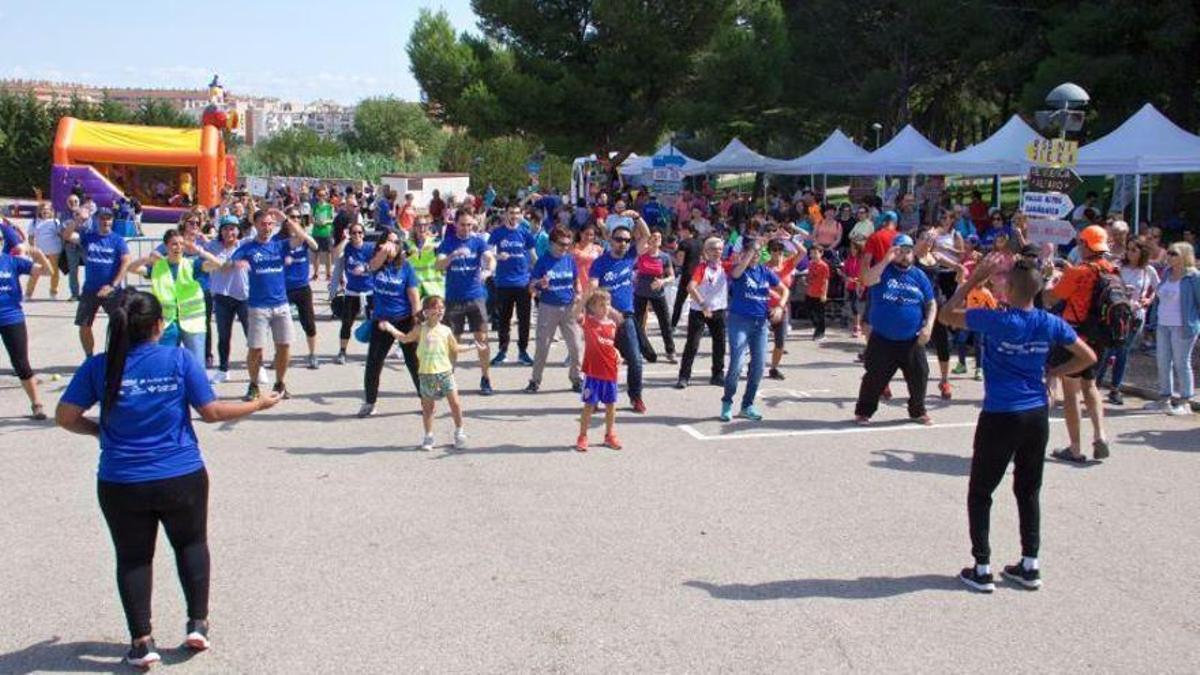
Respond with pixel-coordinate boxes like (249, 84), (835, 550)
(0, 635), (196, 675)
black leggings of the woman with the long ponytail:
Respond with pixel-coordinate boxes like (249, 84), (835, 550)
(96, 468), (209, 639)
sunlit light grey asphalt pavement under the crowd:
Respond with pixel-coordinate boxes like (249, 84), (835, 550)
(0, 290), (1200, 673)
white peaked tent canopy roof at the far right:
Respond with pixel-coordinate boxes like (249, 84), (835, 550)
(1075, 103), (1200, 175)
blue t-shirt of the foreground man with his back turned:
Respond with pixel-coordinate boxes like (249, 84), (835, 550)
(966, 309), (1076, 412)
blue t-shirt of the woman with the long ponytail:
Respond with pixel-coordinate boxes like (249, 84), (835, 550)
(61, 342), (216, 483)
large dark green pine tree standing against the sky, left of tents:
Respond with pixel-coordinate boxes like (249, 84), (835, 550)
(408, 0), (727, 162)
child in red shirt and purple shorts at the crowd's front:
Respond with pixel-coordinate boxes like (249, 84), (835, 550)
(575, 288), (624, 453)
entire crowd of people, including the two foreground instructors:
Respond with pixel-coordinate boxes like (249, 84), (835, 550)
(0, 172), (1200, 665)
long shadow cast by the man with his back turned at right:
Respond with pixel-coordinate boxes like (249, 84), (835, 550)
(683, 574), (962, 601)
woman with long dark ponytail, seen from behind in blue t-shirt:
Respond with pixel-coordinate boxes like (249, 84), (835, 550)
(55, 285), (280, 668)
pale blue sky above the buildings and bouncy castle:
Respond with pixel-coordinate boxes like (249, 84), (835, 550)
(0, 0), (475, 104)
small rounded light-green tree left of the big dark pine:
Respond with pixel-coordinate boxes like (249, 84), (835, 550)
(346, 97), (445, 161)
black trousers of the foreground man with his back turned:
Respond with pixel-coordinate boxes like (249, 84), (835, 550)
(967, 407), (1050, 565)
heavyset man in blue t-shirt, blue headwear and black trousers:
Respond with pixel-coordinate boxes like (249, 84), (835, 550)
(854, 234), (937, 425)
